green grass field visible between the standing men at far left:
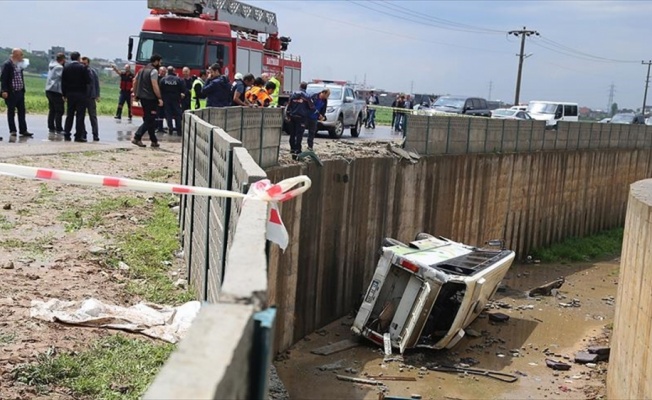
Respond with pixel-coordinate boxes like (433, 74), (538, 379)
(0, 74), (120, 115)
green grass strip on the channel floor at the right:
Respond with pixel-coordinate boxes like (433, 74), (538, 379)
(532, 228), (624, 263)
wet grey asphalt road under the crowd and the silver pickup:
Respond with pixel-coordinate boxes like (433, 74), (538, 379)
(0, 114), (400, 145)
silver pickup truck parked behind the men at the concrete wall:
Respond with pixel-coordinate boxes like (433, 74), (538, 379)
(307, 82), (366, 139)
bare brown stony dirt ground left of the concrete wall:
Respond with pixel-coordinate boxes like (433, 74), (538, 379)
(0, 143), (181, 399)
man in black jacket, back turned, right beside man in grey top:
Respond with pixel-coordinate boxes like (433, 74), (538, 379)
(61, 51), (91, 142)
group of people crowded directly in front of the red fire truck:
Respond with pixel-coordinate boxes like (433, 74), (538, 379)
(123, 54), (281, 147)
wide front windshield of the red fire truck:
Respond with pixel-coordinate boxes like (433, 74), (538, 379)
(136, 39), (204, 68)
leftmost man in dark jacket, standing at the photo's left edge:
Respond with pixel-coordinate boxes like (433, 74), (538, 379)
(0, 49), (34, 136)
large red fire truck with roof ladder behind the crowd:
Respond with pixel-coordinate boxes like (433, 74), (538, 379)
(128, 0), (301, 115)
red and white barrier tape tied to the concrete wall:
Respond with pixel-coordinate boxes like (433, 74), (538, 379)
(0, 163), (311, 249)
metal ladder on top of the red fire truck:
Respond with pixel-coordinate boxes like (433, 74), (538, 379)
(147, 0), (278, 34)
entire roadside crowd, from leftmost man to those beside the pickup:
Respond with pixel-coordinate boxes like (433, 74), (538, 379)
(0, 49), (290, 148)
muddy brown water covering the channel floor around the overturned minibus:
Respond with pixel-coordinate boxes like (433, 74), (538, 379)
(275, 260), (619, 399)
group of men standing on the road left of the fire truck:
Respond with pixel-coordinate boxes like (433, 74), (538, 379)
(0, 48), (100, 142)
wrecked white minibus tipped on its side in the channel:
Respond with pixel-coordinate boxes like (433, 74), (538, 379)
(351, 233), (514, 353)
